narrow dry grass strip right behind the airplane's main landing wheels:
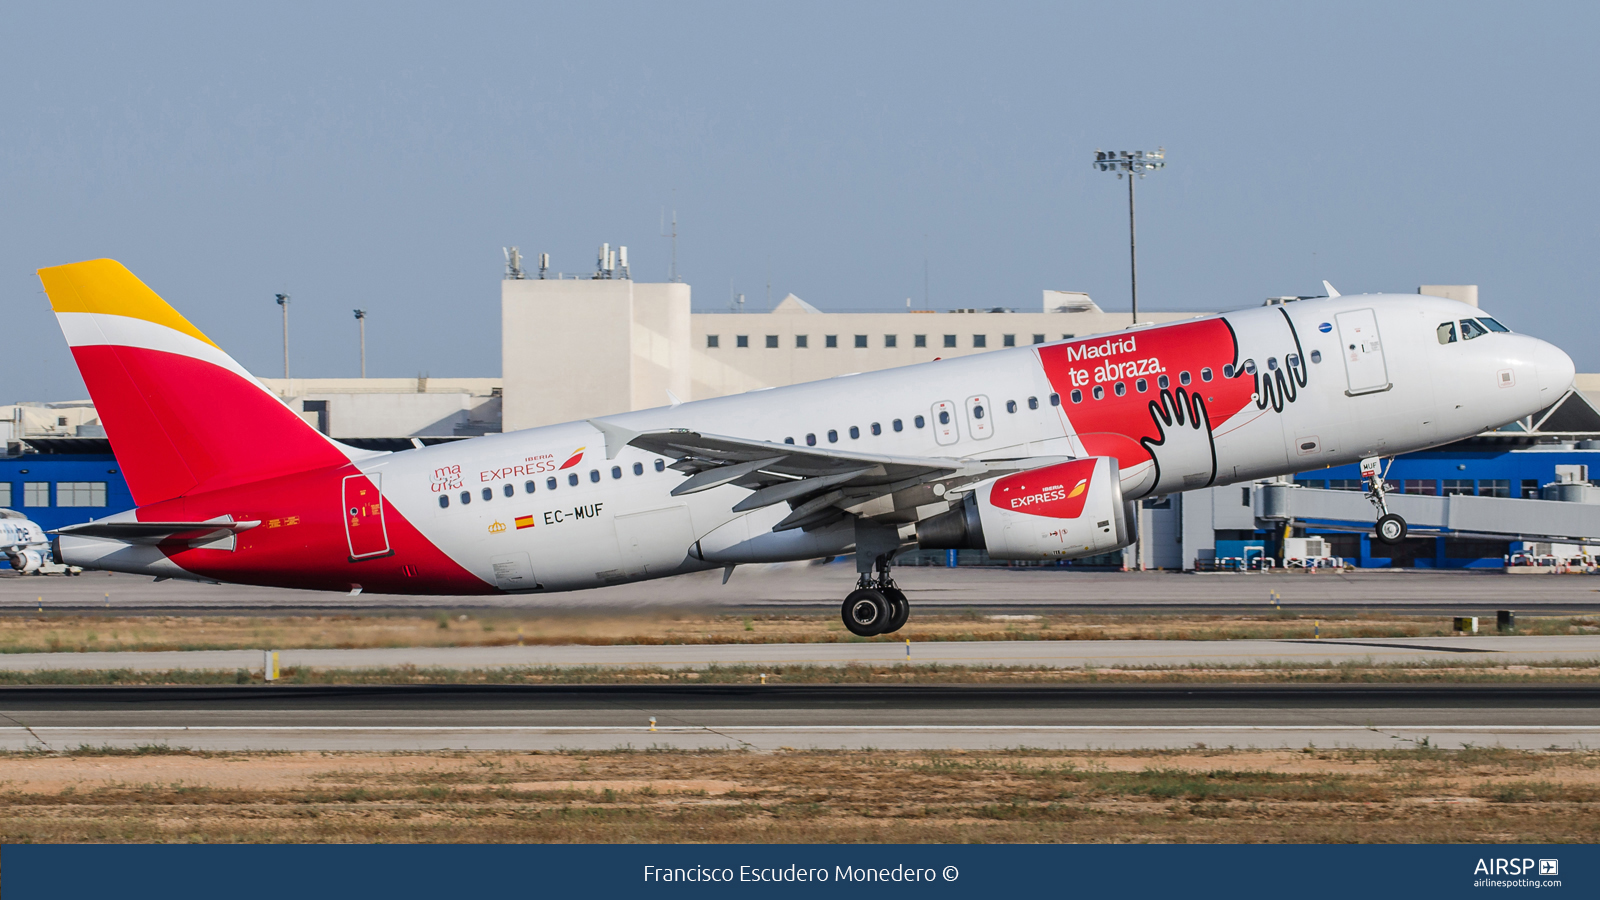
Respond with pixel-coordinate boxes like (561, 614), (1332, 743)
(0, 612), (1600, 653)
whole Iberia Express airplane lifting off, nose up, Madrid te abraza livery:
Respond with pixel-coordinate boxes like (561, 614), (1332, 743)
(38, 259), (1574, 636)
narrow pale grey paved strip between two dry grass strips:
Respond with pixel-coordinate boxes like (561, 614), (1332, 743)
(0, 634), (1600, 671)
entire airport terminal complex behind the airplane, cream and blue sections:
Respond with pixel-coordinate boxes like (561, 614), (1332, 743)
(0, 253), (1600, 569)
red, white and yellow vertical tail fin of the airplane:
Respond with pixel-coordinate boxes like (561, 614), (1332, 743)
(38, 259), (350, 506)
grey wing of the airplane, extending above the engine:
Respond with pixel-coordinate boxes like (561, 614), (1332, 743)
(589, 420), (1064, 532)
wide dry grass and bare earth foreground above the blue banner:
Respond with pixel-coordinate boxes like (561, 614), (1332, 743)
(0, 748), (1600, 842)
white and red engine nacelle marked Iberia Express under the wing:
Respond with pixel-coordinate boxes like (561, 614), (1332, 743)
(917, 456), (1138, 559)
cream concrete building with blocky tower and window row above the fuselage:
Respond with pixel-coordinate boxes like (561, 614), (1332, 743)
(501, 279), (1195, 431)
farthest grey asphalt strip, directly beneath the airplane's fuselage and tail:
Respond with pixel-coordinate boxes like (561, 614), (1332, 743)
(0, 562), (1600, 617)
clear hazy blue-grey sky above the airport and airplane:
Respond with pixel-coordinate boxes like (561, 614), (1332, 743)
(0, 2), (1600, 395)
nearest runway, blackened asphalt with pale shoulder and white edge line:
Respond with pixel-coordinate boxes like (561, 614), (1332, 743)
(0, 684), (1600, 751)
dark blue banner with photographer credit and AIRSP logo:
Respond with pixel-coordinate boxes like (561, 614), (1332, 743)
(0, 844), (1600, 900)
